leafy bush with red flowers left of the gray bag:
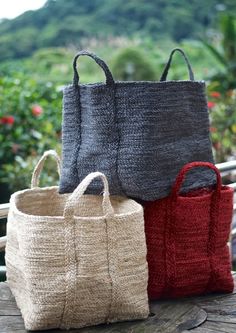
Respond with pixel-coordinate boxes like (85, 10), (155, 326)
(0, 73), (61, 196)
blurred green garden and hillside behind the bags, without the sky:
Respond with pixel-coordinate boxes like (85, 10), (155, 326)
(0, 0), (236, 202)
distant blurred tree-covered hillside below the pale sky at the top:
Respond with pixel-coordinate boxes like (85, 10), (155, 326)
(0, 0), (236, 60)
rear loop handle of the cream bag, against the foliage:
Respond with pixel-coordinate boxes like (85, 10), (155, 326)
(31, 150), (61, 188)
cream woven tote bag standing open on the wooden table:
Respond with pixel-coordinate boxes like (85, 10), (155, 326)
(6, 153), (149, 330)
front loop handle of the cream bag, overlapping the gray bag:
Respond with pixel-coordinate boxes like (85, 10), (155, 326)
(63, 172), (114, 218)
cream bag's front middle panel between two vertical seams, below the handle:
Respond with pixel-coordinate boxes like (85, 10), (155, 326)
(71, 218), (111, 328)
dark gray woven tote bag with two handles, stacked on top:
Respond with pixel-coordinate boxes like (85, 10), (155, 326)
(60, 49), (214, 200)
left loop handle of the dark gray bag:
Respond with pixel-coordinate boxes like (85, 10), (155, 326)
(73, 51), (115, 85)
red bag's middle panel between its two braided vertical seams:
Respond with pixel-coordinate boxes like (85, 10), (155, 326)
(171, 194), (212, 297)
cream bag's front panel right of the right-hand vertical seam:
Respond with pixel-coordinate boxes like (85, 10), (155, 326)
(108, 211), (149, 322)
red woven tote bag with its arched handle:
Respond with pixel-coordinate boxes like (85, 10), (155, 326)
(144, 162), (234, 299)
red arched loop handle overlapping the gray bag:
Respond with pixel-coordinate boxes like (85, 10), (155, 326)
(171, 162), (222, 198)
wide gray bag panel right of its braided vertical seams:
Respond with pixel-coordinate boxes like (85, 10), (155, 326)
(117, 82), (215, 200)
